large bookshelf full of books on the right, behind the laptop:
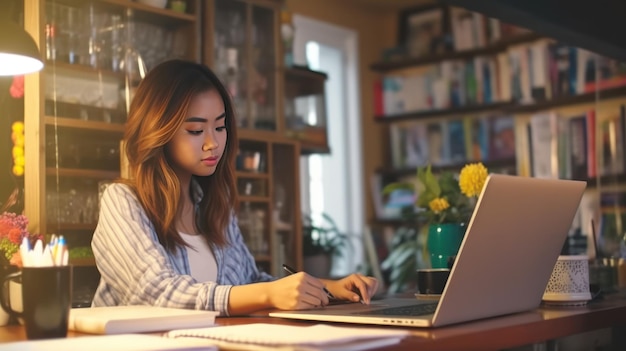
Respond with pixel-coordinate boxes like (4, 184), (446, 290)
(370, 1), (626, 296)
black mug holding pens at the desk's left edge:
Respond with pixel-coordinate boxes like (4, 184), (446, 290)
(0, 266), (72, 340)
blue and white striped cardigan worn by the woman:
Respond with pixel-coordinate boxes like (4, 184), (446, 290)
(91, 183), (275, 315)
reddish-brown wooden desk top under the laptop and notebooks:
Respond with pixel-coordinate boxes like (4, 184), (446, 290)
(0, 296), (626, 351)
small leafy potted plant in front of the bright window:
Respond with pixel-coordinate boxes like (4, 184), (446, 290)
(302, 213), (351, 278)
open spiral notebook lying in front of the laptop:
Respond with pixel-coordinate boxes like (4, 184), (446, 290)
(163, 323), (410, 351)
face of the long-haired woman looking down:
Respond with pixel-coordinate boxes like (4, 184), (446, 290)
(165, 89), (228, 180)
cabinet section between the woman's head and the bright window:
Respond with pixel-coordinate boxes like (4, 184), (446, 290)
(203, 0), (302, 275)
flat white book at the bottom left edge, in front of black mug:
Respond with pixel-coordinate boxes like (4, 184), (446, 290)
(0, 334), (217, 351)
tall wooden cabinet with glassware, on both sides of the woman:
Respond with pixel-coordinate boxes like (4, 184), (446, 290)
(24, 0), (301, 274)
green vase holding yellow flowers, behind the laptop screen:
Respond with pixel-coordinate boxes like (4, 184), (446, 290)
(428, 223), (465, 268)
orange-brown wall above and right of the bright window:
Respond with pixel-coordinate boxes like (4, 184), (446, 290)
(286, 0), (397, 223)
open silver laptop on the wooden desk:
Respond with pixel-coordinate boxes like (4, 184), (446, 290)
(269, 174), (586, 327)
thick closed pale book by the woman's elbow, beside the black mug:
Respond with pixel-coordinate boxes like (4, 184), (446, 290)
(68, 306), (218, 334)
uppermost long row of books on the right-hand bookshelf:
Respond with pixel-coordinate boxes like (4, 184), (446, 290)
(374, 39), (626, 117)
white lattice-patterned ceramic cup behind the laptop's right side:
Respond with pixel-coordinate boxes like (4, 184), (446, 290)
(543, 255), (591, 303)
